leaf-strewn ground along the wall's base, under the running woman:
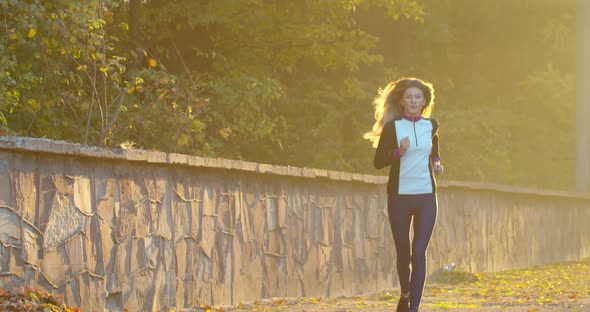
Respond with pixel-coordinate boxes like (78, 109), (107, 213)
(209, 259), (590, 312)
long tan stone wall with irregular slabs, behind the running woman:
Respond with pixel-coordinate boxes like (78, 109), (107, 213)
(0, 137), (590, 311)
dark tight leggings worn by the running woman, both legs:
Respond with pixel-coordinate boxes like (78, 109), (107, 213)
(387, 193), (438, 311)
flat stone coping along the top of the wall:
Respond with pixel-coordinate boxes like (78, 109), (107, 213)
(0, 136), (590, 200)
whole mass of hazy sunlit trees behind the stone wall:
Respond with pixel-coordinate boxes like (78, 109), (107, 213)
(0, 0), (576, 190)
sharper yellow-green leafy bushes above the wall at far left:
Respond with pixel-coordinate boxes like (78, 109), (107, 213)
(0, 0), (206, 147)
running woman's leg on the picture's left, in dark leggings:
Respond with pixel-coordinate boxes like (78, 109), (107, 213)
(387, 195), (412, 294)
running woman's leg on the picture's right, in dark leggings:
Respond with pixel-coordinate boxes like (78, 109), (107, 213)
(410, 194), (438, 311)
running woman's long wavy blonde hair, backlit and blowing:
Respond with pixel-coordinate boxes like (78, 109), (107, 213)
(363, 78), (434, 148)
